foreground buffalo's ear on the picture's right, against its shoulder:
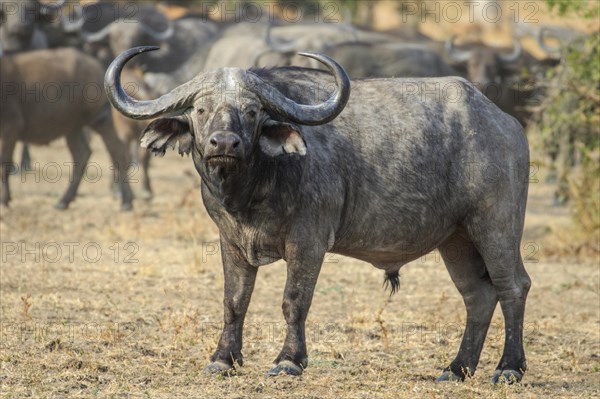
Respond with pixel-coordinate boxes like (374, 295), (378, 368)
(259, 120), (306, 157)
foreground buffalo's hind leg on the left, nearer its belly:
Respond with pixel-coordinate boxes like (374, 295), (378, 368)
(437, 231), (498, 381)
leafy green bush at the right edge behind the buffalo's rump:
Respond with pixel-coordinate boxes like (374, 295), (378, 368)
(530, 0), (600, 248)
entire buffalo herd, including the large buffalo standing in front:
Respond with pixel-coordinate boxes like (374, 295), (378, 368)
(0, 0), (580, 383)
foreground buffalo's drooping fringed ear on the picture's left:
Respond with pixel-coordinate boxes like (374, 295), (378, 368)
(140, 118), (194, 157)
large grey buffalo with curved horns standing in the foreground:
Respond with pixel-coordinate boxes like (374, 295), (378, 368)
(105, 47), (530, 382)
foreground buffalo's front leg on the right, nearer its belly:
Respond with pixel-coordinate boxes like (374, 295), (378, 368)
(268, 245), (325, 376)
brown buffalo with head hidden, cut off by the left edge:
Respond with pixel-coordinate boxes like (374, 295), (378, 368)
(0, 48), (132, 209)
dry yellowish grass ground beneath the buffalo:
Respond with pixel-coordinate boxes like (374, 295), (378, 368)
(0, 138), (600, 398)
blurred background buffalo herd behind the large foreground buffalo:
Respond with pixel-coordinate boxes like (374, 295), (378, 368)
(0, 0), (565, 208)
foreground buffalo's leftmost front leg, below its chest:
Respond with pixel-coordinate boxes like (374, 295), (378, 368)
(204, 236), (257, 373)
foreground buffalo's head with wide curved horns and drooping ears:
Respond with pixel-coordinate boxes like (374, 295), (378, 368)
(105, 47), (350, 178)
